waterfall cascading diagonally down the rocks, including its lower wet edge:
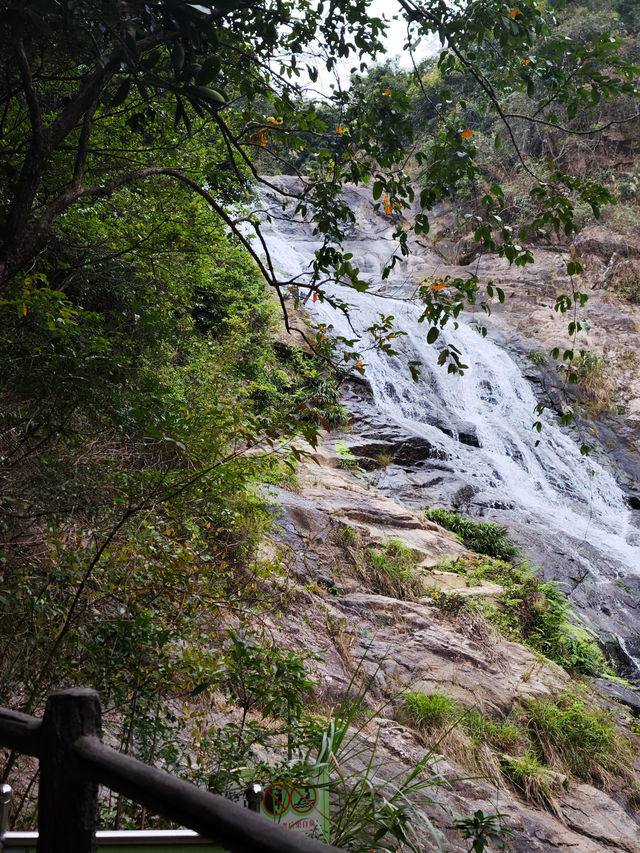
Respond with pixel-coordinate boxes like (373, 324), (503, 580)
(254, 178), (640, 672)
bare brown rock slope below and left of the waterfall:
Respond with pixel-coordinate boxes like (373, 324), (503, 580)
(272, 446), (640, 853)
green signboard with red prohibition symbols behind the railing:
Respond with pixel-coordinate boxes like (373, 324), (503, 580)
(260, 776), (329, 840)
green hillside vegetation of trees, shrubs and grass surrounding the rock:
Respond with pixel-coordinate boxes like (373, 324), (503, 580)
(0, 0), (640, 851)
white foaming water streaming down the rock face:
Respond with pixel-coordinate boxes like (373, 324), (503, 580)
(256, 183), (640, 577)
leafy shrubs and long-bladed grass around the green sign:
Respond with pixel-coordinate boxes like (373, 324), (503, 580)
(205, 648), (456, 853)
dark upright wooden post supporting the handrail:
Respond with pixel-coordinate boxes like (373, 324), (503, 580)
(37, 687), (101, 853)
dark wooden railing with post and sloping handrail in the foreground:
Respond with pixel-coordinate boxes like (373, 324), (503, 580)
(0, 687), (339, 853)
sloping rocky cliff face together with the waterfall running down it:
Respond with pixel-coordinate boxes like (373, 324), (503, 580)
(251, 178), (640, 853)
